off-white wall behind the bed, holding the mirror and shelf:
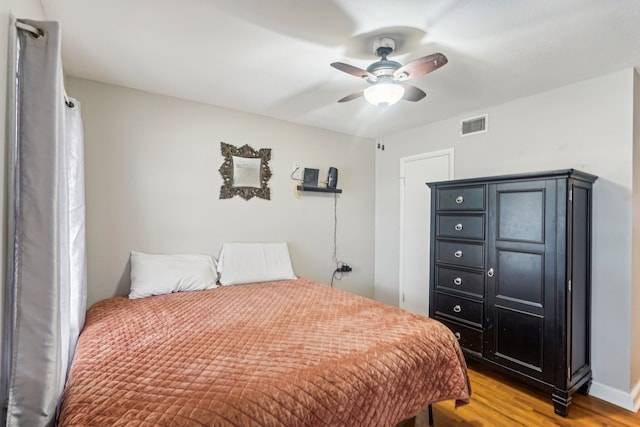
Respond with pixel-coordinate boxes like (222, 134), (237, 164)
(67, 79), (374, 304)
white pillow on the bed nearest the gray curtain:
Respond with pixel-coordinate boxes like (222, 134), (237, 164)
(129, 252), (218, 299)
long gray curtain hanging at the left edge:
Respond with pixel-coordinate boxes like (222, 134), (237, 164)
(3, 20), (86, 426)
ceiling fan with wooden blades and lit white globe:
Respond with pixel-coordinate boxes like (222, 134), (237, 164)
(331, 37), (448, 106)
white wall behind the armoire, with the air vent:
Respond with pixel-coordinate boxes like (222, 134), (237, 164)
(375, 69), (638, 407)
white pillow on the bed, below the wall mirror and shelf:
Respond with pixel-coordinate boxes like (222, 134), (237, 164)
(218, 243), (296, 285)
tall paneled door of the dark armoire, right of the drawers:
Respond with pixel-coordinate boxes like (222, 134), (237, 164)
(485, 179), (557, 381)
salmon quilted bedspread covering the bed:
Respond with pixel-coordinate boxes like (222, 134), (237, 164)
(59, 279), (471, 427)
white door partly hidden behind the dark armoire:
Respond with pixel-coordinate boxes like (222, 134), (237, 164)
(399, 148), (453, 316)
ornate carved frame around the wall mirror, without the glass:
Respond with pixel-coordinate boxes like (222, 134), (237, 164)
(218, 142), (271, 200)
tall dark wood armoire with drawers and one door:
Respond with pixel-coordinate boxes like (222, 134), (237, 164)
(428, 169), (596, 416)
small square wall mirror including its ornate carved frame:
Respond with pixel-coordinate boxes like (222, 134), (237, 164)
(219, 142), (271, 200)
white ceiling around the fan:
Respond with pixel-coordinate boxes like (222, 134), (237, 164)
(42, 0), (640, 138)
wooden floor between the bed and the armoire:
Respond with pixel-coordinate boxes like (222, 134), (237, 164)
(406, 365), (640, 427)
